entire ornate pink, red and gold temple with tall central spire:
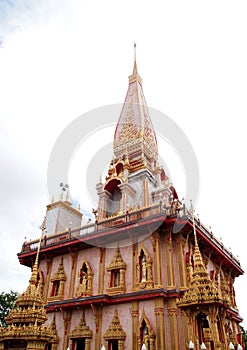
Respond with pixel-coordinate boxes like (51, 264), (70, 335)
(0, 47), (243, 350)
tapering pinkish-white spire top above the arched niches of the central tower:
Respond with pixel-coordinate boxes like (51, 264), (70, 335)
(114, 44), (158, 169)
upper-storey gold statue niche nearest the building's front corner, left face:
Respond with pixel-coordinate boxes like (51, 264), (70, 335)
(136, 246), (154, 289)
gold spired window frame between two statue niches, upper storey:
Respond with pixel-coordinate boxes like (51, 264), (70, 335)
(106, 248), (127, 295)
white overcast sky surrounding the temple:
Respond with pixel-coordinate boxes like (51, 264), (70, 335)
(0, 0), (247, 326)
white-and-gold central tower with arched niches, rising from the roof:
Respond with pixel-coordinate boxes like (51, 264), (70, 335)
(96, 44), (172, 221)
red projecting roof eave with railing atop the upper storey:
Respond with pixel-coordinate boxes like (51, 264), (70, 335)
(18, 208), (244, 277)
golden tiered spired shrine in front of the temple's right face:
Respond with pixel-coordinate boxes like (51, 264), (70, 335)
(177, 214), (233, 349)
